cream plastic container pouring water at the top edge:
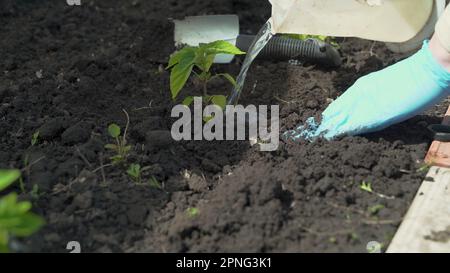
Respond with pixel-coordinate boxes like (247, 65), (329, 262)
(269, 0), (445, 43)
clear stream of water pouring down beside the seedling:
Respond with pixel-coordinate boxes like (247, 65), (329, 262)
(228, 20), (273, 105)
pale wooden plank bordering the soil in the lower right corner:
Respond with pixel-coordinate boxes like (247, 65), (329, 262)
(387, 167), (450, 253)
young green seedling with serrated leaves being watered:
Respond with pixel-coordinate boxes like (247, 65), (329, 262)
(166, 41), (245, 109)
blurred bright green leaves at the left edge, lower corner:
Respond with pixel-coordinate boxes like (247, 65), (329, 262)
(0, 170), (44, 253)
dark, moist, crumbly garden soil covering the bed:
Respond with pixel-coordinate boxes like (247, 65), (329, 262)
(0, 0), (445, 252)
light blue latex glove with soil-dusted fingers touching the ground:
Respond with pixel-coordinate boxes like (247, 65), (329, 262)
(284, 41), (450, 140)
